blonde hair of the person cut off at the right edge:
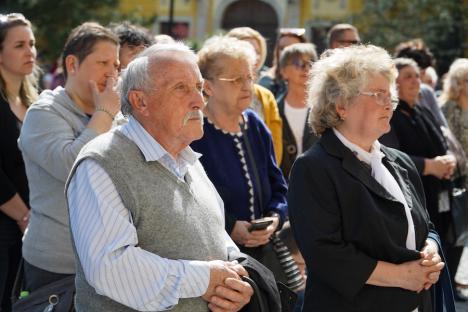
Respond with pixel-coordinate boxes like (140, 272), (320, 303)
(441, 58), (468, 104)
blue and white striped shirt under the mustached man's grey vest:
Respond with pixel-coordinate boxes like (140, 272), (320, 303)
(68, 117), (238, 311)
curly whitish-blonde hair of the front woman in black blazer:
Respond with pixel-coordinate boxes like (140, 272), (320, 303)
(307, 45), (397, 135)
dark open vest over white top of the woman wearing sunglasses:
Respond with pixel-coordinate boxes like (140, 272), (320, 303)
(277, 94), (318, 180)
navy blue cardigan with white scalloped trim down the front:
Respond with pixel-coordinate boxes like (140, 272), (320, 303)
(191, 109), (287, 233)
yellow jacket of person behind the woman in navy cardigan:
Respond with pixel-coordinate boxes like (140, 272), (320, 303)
(254, 84), (283, 166)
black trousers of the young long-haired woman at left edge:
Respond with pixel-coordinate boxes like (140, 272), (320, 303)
(0, 240), (21, 312)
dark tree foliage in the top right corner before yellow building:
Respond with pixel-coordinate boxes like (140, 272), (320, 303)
(352, 0), (468, 73)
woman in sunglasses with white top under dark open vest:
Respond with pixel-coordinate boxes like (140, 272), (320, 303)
(277, 43), (317, 180)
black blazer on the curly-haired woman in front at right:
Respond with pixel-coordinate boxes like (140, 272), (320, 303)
(288, 129), (429, 312)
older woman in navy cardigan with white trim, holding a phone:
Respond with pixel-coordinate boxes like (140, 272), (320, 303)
(192, 37), (287, 280)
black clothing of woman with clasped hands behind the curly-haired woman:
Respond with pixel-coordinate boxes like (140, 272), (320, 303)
(379, 100), (451, 236)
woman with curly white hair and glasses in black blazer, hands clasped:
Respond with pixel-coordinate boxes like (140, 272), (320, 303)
(288, 45), (444, 312)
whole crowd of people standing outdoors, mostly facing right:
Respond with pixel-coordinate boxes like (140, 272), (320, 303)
(0, 13), (468, 312)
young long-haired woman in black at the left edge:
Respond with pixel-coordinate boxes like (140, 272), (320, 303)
(0, 14), (37, 311)
